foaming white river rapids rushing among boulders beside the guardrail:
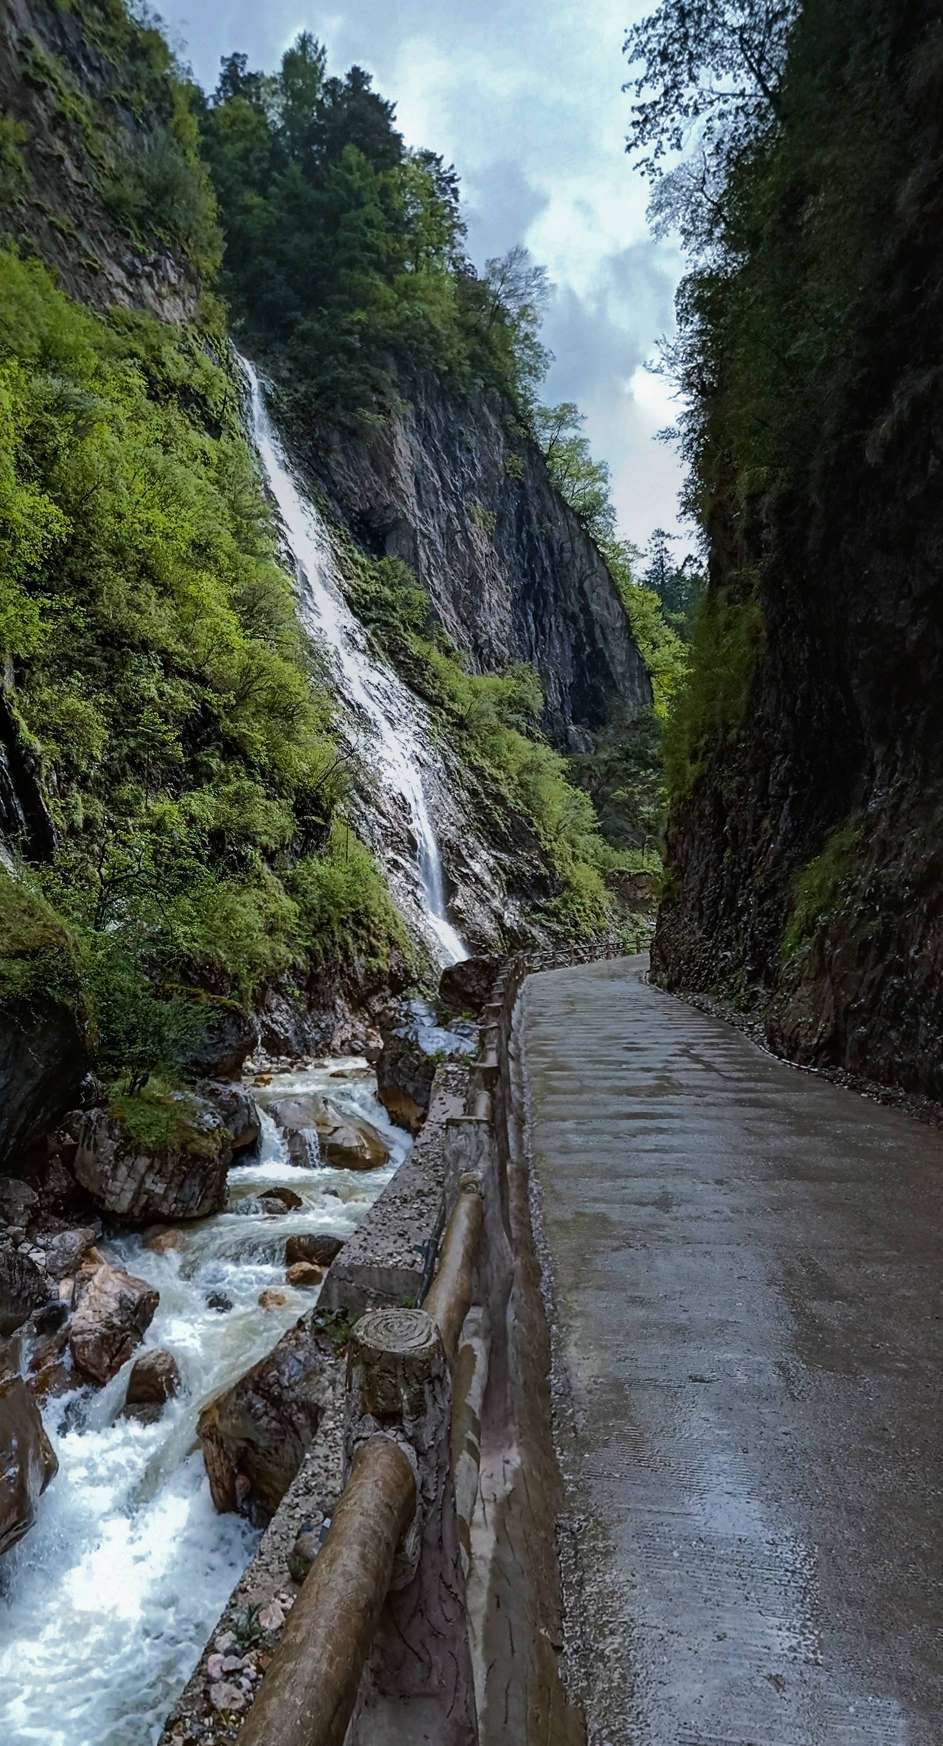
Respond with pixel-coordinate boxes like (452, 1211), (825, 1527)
(0, 1060), (410, 1746)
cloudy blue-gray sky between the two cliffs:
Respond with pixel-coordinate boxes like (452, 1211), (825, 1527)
(159, 0), (681, 545)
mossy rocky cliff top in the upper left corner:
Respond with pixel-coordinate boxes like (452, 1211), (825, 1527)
(0, 0), (215, 321)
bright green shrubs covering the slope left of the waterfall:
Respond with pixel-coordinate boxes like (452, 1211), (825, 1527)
(0, 255), (398, 1095)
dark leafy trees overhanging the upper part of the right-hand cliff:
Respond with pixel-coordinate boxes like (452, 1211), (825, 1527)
(629, 0), (922, 841)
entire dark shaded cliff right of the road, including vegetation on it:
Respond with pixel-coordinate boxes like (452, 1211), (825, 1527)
(653, 0), (943, 1098)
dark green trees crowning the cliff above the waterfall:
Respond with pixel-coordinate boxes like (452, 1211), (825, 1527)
(203, 31), (547, 419)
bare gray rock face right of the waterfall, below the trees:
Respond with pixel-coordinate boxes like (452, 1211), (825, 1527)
(307, 377), (651, 751)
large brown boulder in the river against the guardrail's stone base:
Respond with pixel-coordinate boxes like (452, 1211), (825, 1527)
(199, 1316), (334, 1523)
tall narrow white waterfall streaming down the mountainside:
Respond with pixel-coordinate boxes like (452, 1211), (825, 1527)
(239, 358), (468, 964)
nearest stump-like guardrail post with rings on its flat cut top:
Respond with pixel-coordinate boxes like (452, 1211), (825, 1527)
(346, 1310), (478, 1746)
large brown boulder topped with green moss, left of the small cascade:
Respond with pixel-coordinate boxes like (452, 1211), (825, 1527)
(75, 1086), (258, 1224)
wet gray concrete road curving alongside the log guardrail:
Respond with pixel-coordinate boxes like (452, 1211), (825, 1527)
(520, 959), (943, 1746)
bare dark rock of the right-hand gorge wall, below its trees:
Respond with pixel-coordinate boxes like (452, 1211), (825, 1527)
(653, 3), (943, 1098)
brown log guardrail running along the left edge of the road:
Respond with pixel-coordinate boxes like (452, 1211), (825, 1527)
(232, 959), (555, 1746)
